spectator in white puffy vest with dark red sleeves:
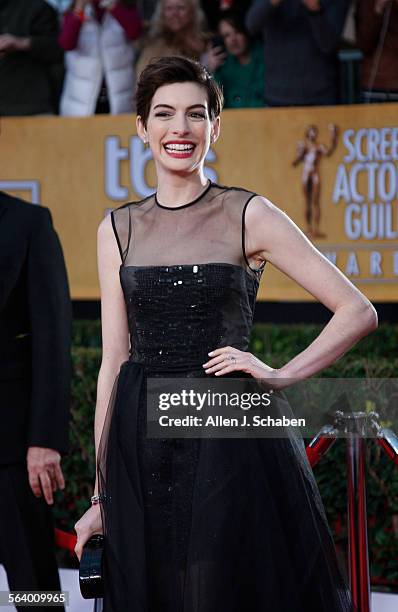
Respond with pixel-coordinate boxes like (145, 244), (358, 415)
(59, 0), (142, 116)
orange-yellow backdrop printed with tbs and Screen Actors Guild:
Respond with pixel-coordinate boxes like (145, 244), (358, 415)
(0, 104), (398, 301)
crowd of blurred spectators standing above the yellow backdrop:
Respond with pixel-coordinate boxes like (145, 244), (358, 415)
(0, 0), (398, 116)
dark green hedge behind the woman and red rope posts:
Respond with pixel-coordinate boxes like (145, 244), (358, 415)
(54, 321), (398, 585)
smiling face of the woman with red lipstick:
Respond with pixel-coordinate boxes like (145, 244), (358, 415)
(137, 82), (220, 176)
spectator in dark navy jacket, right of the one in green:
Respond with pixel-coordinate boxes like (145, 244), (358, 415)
(246, 0), (350, 106)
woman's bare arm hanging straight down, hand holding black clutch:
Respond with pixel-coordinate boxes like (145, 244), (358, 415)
(75, 215), (129, 559)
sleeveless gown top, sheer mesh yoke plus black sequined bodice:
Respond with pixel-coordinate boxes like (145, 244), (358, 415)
(112, 183), (268, 371)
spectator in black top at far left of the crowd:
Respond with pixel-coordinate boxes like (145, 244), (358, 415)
(0, 0), (62, 115)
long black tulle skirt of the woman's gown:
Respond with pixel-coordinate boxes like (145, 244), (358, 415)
(98, 361), (354, 612)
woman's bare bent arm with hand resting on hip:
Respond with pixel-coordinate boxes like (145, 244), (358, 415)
(206, 196), (377, 380)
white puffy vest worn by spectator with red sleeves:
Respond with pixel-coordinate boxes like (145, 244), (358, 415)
(60, 13), (135, 116)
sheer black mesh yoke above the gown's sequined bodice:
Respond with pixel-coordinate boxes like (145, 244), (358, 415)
(111, 180), (264, 280)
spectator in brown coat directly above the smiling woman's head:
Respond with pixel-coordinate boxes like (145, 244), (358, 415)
(136, 0), (208, 78)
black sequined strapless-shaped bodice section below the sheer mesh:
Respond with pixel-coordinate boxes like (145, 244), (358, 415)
(121, 263), (258, 369)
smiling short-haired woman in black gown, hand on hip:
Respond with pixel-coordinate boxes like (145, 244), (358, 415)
(76, 57), (377, 612)
